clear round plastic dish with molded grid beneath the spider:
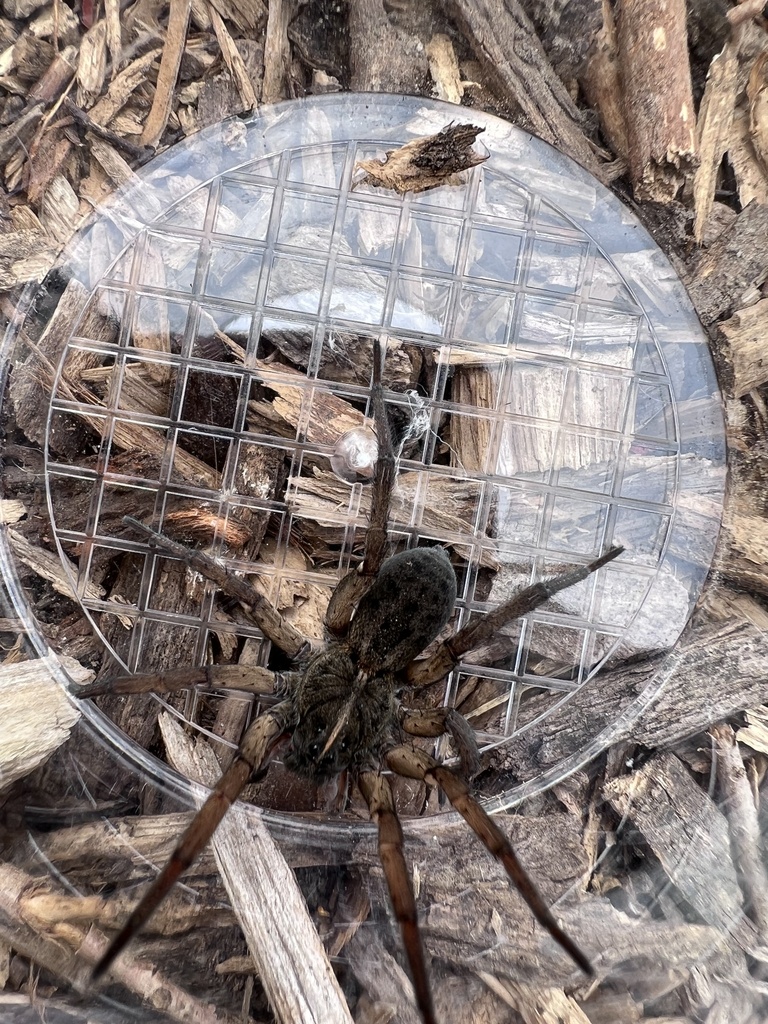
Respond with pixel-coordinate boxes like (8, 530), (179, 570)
(2, 94), (725, 1015)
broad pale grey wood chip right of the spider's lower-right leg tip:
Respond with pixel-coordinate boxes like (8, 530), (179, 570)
(603, 754), (744, 937)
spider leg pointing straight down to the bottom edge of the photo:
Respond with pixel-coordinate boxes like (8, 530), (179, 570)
(357, 771), (436, 1024)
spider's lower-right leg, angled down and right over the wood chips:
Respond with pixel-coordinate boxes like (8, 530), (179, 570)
(385, 746), (595, 975)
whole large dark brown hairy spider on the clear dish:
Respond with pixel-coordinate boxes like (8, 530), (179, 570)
(83, 341), (623, 1024)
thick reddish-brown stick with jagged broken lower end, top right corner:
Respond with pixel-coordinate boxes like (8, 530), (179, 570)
(618, 0), (696, 203)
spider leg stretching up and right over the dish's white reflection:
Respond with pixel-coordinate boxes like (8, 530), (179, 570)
(407, 547), (624, 686)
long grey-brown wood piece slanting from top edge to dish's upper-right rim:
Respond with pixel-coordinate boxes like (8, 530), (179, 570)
(449, 0), (600, 177)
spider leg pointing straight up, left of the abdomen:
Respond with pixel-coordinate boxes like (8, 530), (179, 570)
(326, 338), (397, 637)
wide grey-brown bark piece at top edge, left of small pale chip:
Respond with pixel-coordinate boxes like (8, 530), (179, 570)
(349, 0), (429, 92)
